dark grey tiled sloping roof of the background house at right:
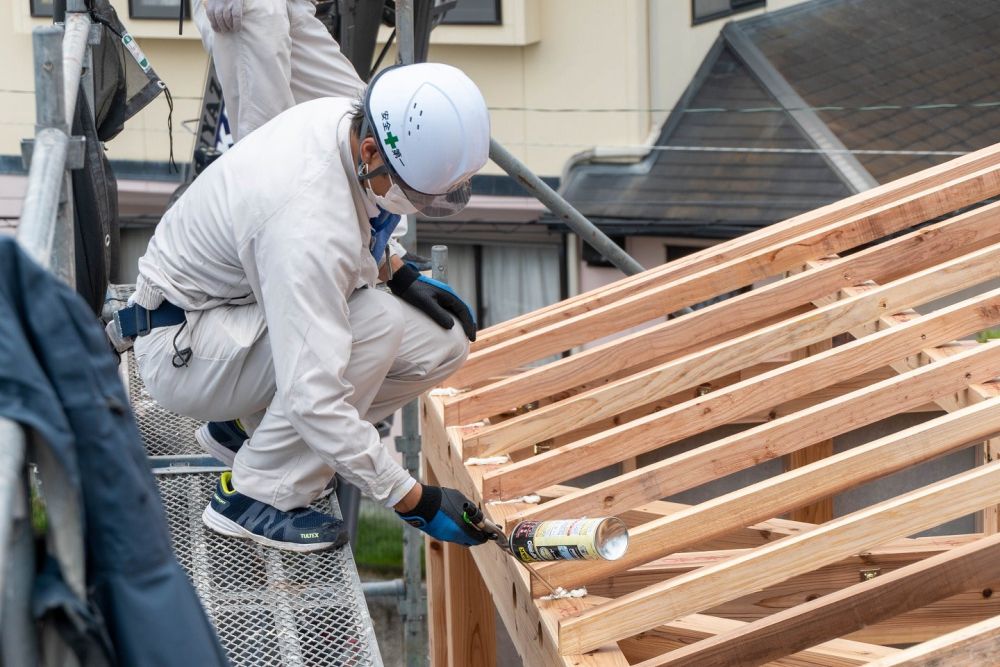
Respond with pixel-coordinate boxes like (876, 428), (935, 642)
(550, 0), (1000, 298)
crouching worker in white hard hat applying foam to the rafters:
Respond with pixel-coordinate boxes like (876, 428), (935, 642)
(112, 63), (490, 551)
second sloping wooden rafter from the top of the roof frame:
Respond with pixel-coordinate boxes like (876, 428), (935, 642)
(449, 166), (1000, 387)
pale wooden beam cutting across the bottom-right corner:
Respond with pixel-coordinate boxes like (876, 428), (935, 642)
(868, 616), (1000, 667)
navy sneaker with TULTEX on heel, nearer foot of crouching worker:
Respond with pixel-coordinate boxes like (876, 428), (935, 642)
(201, 470), (350, 552)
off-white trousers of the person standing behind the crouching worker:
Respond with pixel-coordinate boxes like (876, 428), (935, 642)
(194, 0), (364, 141)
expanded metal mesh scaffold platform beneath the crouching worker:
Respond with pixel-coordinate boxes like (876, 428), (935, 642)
(113, 332), (382, 667)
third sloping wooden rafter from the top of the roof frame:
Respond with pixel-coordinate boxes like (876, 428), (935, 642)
(445, 203), (1000, 424)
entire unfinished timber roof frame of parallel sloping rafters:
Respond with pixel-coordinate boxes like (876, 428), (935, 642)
(425, 145), (1000, 667)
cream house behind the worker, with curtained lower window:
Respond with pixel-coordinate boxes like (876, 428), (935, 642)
(0, 0), (801, 325)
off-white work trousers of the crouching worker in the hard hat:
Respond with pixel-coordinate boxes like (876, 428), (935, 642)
(135, 289), (469, 510)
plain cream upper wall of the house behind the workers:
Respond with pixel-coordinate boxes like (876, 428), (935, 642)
(0, 0), (801, 176)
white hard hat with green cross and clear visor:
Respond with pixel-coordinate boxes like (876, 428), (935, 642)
(362, 63), (490, 217)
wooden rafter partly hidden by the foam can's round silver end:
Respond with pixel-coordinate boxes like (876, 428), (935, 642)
(546, 394), (1000, 587)
